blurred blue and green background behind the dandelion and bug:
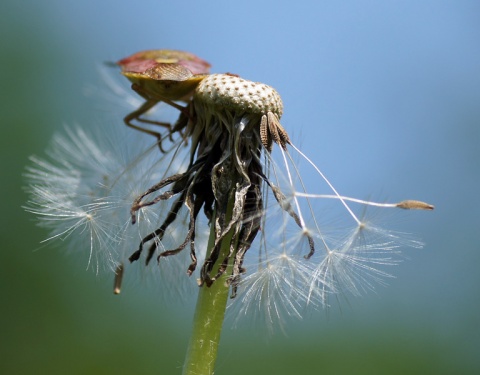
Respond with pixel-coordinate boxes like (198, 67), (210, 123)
(0, 0), (480, 374)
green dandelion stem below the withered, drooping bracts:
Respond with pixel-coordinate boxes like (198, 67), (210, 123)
(183, 194), (234, 375)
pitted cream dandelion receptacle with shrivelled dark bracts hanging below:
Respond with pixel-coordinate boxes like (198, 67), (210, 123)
(126, 74), (314, 295)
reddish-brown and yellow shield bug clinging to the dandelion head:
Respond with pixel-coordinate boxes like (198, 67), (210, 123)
(117, 50), (210, 149)
